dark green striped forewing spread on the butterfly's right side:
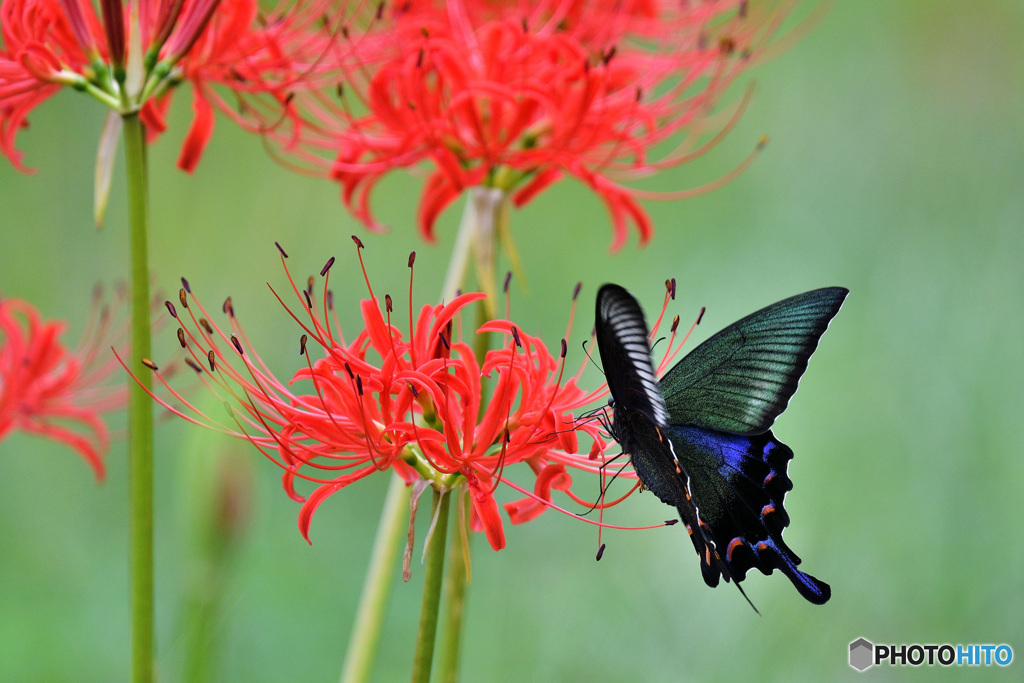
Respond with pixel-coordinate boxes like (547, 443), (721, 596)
(659, 287), (849, 434)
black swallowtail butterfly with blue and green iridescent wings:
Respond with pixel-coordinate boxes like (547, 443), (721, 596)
(595, 285), (849, 609)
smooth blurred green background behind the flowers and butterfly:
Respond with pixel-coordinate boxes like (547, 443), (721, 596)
(0, 0), (1024, 681)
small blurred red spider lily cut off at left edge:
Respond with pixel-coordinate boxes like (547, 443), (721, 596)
(0, 290), (138, 480)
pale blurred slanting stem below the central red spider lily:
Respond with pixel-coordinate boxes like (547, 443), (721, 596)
(341, 475), (410, 683)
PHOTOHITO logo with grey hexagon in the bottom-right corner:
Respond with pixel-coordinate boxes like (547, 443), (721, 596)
(850, 638), (1014, 671)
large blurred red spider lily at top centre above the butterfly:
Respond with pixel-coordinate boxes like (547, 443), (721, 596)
(289, 0), (792, 250)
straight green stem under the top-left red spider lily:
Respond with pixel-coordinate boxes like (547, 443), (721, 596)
(124, 115), (154, 683)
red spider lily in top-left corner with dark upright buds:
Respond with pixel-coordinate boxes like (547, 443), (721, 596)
(0, 0), (344, 171)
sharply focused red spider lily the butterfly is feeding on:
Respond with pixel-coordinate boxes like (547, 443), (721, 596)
(125, 238), (688, 550)
